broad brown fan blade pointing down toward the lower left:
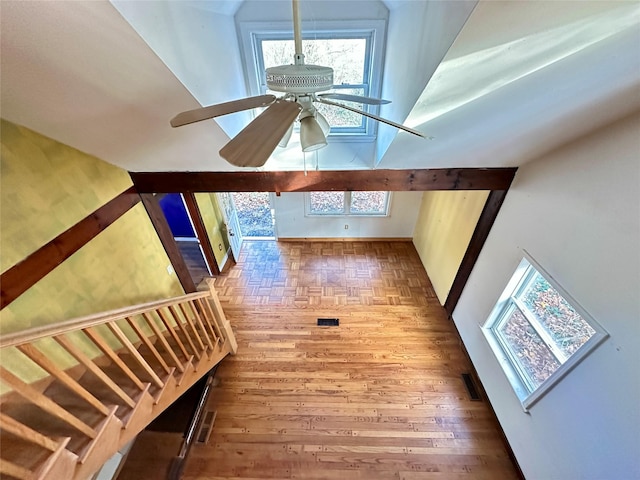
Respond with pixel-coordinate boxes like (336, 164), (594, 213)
(220, 100), (302, 167)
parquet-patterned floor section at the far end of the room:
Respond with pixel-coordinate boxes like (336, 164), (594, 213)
(216, 241), (438, 307)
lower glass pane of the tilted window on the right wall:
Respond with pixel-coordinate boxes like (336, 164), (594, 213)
(498, 308), (560, 389)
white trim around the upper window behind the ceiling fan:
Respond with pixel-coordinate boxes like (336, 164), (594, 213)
(238, 19), (387, 142)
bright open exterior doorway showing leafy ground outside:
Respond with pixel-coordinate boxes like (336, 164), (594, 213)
(231, 192), (276, 240)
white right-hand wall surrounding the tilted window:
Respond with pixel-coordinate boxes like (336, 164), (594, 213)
(453, 114), (640, 480)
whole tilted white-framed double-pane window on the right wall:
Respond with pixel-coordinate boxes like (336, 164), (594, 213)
(483, 256), (607, 411)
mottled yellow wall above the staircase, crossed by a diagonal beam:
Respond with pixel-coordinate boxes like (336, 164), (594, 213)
(0, 121), (184, 372)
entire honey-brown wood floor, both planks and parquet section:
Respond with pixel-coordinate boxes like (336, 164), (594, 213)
(183, 241), (518, 480)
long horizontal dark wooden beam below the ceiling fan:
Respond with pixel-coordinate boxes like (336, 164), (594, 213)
(130, 168), (517, 193)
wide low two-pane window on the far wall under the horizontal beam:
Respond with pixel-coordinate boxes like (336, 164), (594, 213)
(305, 192), (389, 216)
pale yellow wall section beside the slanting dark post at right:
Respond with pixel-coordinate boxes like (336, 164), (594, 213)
(413, 191), (489, 304)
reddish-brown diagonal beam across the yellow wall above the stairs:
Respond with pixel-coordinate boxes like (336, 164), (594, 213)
(0, 187), (140, 308)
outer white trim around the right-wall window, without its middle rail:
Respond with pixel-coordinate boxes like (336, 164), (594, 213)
(481, 251), (609, 412)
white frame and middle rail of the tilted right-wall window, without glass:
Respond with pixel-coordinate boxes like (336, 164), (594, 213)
(481, 251), (609, 412)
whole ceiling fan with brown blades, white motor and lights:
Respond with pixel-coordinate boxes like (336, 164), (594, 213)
(170, 0), (424, 167)
